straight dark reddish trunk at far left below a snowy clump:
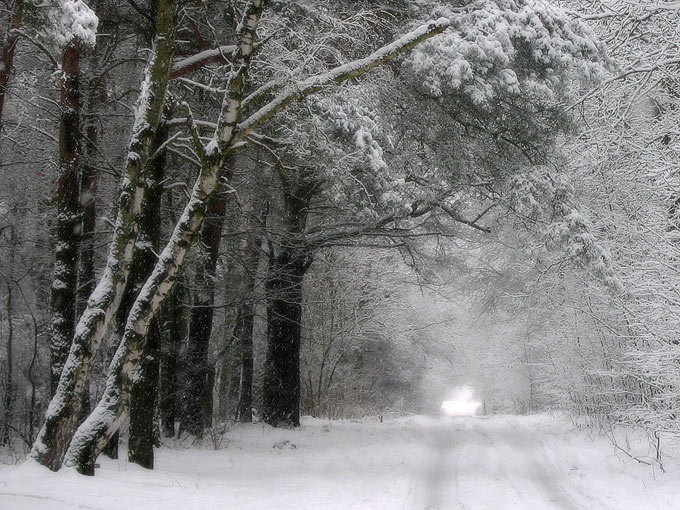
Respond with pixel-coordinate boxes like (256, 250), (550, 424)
(50, 39), (81, 395)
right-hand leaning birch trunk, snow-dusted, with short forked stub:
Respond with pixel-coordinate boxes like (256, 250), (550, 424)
(64, 0), (263, 474)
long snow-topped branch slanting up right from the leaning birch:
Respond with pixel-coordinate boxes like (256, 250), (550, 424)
(235, 18), (451, 141)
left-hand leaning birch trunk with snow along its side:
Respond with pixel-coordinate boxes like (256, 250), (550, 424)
(31, 0), (177, 471)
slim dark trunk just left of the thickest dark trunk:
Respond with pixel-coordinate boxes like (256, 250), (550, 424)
(235, 196), (267, 423)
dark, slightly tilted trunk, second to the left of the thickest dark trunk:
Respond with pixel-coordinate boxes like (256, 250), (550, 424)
(181, 189), (231, 438)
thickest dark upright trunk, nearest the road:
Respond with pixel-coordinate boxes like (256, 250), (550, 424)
(262, 173), (318, 427)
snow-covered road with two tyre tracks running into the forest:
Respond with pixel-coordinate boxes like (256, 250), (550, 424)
(417, 418), (596, 510)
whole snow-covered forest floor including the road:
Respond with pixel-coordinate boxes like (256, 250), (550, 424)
(0, 415), (680, 510)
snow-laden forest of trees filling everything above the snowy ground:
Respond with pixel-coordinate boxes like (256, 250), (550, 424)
(0, 0), (680, 473)
